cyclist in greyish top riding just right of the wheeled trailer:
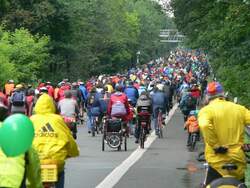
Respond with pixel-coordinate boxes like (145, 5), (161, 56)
(135, 91), (152, 144)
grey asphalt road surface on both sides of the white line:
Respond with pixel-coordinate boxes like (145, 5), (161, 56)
(65, 110), (204, 188)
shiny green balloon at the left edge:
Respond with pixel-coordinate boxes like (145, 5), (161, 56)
(0, 114), (34, 157)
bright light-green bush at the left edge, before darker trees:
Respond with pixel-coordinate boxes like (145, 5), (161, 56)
(0, 27), (49, 83)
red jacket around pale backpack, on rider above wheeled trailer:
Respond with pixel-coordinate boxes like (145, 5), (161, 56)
(107, 92), (130, 121)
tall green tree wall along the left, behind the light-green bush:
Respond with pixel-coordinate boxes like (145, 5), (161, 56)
(0, 0), (174, 81)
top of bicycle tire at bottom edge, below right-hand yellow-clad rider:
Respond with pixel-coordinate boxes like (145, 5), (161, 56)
(210, 177), (247, 188)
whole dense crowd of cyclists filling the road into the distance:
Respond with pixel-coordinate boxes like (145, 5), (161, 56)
(0, 50), (250, 188)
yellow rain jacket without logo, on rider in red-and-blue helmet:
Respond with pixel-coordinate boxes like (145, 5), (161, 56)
(198, 98), (250, 179)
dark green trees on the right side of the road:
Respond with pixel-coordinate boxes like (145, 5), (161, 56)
(172, 0), (250, 106)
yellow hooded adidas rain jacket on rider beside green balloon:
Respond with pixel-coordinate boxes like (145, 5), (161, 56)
(30, 94), (79, 172)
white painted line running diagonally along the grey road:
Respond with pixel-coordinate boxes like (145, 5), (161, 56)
(96, 104), (178, 188)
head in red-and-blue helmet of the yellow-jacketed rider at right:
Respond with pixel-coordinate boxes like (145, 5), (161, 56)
(206, 82), (225, 101)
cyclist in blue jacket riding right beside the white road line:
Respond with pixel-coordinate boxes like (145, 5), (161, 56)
(151, 85), (169, 135)
